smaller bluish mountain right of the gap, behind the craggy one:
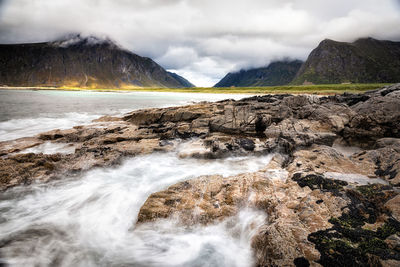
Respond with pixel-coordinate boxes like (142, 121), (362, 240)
(214, 60), (302, 87)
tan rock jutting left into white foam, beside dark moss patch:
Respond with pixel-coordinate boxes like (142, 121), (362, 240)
(138, 168), (346, 266)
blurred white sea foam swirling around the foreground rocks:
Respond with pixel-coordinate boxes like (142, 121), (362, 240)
(0, 153), (271, 266)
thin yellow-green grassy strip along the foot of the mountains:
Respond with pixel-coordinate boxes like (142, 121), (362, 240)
(0, 83), (390, 95)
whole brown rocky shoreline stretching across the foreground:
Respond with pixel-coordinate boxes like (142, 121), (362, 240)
(0, 84), (400, 266)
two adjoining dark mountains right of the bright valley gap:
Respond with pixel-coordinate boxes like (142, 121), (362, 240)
(215, 38), (400, 87)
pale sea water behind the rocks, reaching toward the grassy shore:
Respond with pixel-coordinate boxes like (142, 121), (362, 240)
(0, 90), (245, 141)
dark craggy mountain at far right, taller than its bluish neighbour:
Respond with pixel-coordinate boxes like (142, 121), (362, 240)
(293, 38), (400, 84)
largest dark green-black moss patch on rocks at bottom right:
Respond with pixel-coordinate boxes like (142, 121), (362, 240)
(308, 182), (400, 266)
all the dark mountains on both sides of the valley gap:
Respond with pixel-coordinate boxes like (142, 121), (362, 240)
(0, 34), (400, 88)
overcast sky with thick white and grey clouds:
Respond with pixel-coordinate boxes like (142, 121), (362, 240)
(0, 0), (400, 86)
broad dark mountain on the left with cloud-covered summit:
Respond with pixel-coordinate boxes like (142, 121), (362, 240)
(0, 34), (193, 88)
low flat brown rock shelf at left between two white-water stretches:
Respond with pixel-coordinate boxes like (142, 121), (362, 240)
(0, 121), (170, 190)
